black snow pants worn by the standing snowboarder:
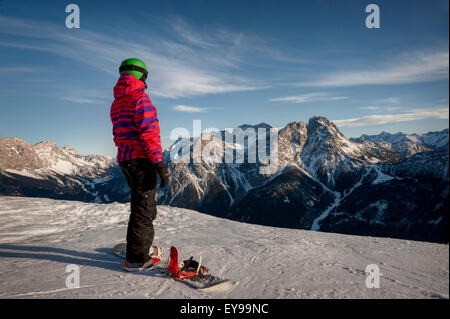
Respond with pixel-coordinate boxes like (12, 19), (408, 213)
(119, 158), (156, 263)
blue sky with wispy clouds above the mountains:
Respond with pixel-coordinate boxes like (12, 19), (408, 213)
(0, 0), (449, 155)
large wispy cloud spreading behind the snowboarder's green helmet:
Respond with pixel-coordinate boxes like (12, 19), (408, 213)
(0, 16), (268, 98)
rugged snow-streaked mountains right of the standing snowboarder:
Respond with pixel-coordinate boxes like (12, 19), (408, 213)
(158, 117), (449, 242)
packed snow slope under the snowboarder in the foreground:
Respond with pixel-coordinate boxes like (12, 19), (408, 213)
(0, 197), (449, 298)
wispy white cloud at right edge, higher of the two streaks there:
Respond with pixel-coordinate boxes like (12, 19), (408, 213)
(297, 52), (449, 87)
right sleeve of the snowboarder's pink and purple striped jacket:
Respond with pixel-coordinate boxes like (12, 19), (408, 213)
(134, 94), (163, 163)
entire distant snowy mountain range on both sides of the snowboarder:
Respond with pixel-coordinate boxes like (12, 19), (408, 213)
(0, 117), (449, 242)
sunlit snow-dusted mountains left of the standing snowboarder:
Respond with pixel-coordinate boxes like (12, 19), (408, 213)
(0, 137), (128, 202)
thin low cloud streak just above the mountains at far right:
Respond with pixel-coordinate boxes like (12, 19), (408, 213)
(333, 106), (449, 127)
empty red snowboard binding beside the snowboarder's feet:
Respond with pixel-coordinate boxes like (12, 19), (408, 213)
(169, 246), (208, 280)
